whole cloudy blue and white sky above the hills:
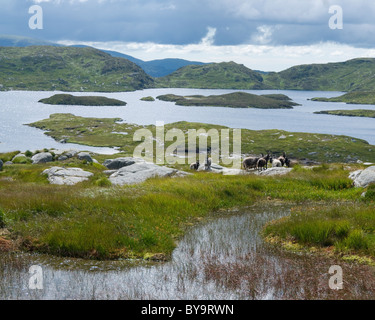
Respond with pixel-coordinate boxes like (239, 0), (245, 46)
(0, 0), (375, 71)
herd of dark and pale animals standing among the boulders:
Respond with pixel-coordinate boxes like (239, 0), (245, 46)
(190, 152), (298, 171)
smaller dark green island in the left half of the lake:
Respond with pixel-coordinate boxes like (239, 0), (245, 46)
(39, 94), (126, 107)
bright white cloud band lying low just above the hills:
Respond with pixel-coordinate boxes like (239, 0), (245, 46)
(60, 38), (375, 71)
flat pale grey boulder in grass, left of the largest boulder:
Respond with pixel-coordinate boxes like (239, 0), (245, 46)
(43, 167), (93, 186)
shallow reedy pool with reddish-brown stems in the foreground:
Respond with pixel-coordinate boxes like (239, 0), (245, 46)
(0, 205), (375, 299)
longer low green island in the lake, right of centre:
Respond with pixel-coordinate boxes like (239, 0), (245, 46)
(156, 92), (298, 109)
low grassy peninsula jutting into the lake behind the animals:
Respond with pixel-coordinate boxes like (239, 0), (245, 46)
(26, 114), (375, 163)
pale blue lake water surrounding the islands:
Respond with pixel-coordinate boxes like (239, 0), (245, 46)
(0, 89), (375, 154)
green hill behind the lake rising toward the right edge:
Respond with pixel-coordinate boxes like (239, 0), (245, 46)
(263, 58), (375, 91)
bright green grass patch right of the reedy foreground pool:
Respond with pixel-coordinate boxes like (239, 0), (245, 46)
(264, 203), (375, 258)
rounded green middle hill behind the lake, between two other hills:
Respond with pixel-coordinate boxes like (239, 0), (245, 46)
(155, 62), (267, 90)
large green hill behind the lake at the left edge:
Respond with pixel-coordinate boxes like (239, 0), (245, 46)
(0, 46), (154, 92)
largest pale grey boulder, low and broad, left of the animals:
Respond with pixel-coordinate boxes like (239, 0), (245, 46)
(109, 162), (181, 186)
